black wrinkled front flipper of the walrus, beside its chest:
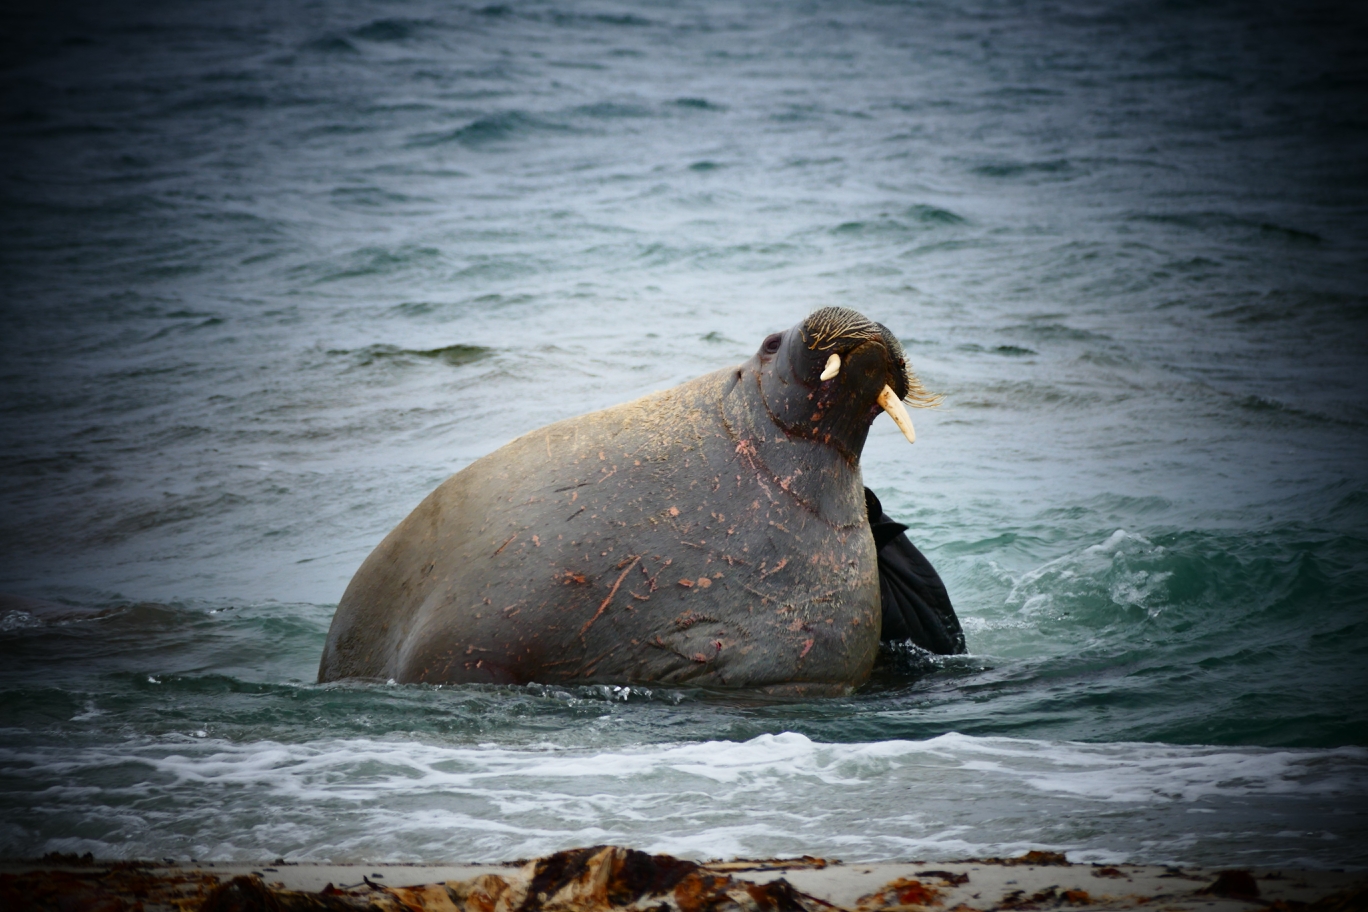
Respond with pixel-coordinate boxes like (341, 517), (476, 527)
(865, 488), (964, 655)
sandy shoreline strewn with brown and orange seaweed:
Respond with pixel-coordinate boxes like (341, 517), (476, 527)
(0, 846), (1368, 912)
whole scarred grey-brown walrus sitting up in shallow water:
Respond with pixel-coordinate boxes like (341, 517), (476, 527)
(319, 308), (963, 695)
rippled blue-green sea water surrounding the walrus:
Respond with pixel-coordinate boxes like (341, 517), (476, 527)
(0, 0), (1368, 868)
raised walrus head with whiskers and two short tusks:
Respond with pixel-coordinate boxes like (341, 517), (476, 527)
(751, 308), (940, 462)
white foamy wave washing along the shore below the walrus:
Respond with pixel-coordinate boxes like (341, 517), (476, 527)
(0, 733), (1368, 861)
